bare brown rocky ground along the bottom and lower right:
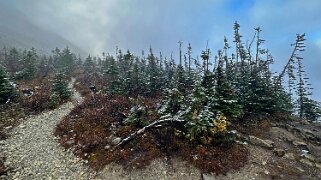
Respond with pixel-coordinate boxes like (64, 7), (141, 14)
(97, 122), (321, 180)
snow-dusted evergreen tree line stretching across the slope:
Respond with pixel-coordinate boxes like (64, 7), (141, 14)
(0, 22), (321, 122)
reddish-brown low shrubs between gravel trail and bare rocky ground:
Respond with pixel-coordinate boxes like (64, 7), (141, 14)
(55, 95), (248, 174)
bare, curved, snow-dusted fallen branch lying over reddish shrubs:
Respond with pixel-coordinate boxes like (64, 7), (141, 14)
(115, 118), (186, 148)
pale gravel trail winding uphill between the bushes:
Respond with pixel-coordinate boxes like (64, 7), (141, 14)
(0, 79), (95, 179)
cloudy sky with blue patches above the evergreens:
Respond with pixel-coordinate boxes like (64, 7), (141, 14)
(0, 0), (321, 100)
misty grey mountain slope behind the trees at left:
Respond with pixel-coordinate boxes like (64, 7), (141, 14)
(0, 7), (86, 56)
